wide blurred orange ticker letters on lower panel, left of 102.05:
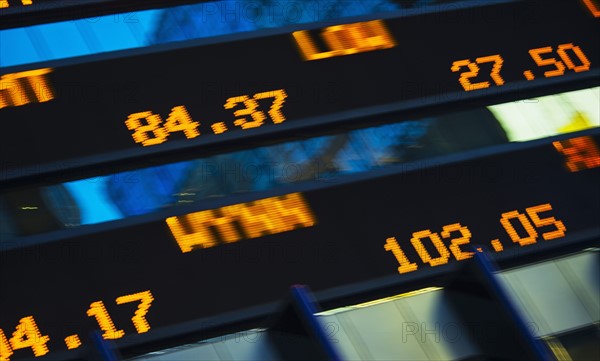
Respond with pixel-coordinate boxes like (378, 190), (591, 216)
(166, 193), (316, 253)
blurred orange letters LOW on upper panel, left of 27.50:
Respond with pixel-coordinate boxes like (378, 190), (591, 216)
(292, 20), (396, 61)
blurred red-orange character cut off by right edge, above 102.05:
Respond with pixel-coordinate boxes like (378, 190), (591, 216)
(552, 136), (600, 172)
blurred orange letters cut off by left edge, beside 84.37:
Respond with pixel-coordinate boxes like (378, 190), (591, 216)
(0, 68), (54, 109)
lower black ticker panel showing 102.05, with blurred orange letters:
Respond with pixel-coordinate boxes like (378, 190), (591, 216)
(0, 130), (600, 360)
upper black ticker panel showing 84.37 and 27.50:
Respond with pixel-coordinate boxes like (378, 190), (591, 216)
(0, 1), (600, 180)
